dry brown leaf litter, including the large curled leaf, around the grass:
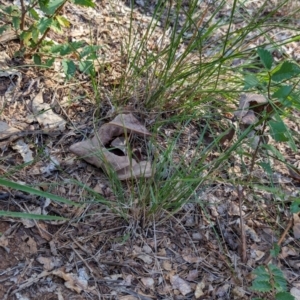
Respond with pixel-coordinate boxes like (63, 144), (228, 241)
(0, 1), (300, 299)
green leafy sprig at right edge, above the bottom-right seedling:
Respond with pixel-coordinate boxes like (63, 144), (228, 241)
(245, 48), (300, 213)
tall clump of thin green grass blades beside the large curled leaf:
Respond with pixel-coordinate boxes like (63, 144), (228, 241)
(1, 0), (300, 227)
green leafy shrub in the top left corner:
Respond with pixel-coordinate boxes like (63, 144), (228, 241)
(0, 0), (99, 79)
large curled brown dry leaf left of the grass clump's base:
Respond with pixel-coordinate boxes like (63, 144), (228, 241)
(70, 114), (152, 180)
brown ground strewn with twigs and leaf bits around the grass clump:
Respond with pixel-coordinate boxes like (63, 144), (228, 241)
(0, 1), (300, 300)
